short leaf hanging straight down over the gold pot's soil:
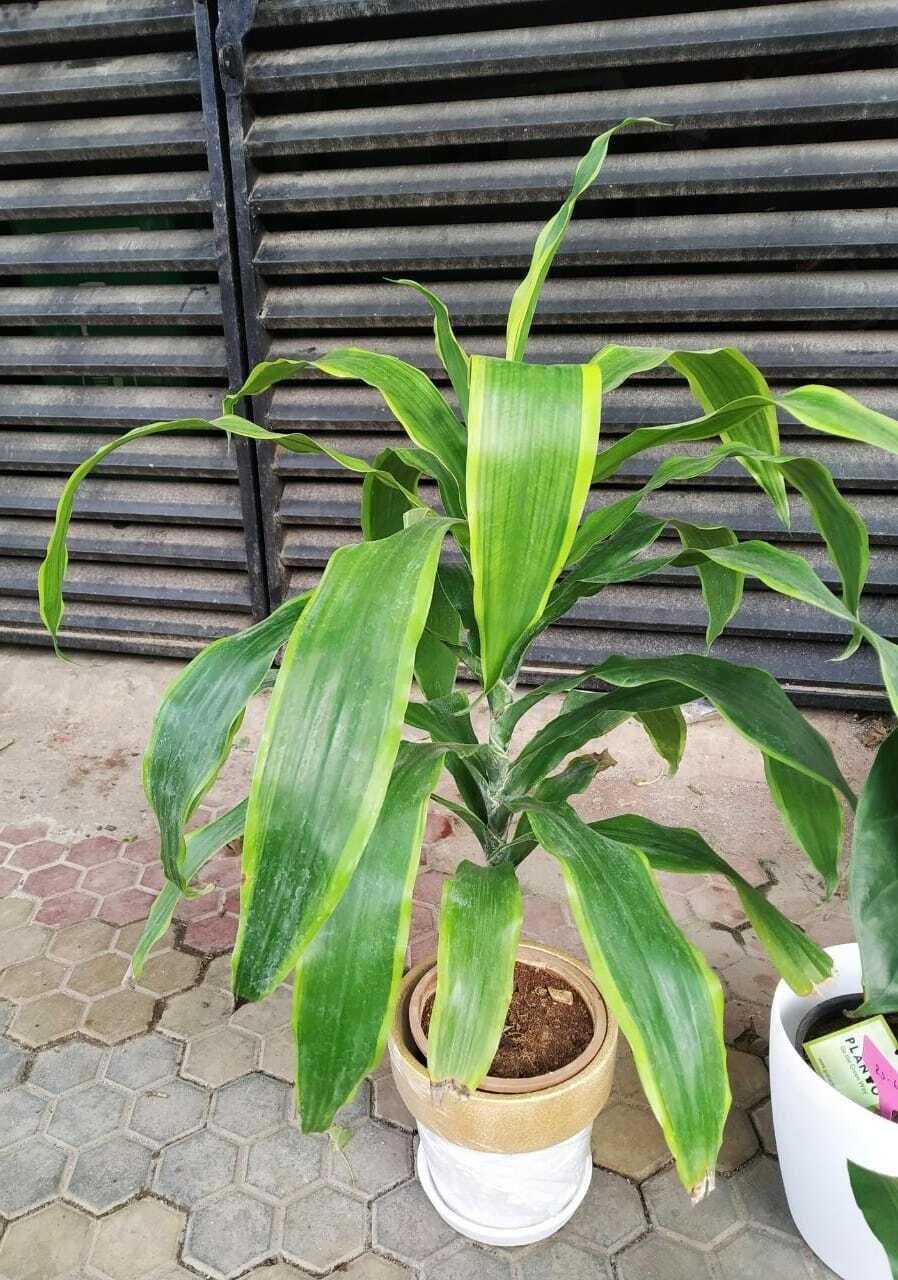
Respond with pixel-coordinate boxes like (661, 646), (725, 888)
(427, 861), (523, 1093)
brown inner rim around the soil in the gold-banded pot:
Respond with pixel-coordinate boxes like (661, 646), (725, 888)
(408, 940), (609, 1094)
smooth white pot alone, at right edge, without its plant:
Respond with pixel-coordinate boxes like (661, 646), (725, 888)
(770, 943), (898, 1280)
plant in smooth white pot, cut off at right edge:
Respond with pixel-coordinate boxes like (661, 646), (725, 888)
(770, 730), (898, 1280)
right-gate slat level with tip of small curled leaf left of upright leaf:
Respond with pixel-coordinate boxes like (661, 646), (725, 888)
(262, 270), (898, 329)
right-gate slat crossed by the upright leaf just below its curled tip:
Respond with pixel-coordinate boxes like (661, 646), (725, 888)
(251, 140), (898, 214)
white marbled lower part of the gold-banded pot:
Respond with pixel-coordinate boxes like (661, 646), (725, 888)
(417, 1124), (592, 1245)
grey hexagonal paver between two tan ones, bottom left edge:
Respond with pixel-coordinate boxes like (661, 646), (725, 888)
(184, 1192), (274, 1277)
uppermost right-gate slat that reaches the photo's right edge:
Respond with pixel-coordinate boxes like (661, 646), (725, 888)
(247, 0), (898, 93)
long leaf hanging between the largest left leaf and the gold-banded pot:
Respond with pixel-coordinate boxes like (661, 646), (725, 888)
(293, 742), (443, 1133)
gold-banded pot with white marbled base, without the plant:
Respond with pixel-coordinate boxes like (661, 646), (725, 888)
(389, 943), (618, 1244)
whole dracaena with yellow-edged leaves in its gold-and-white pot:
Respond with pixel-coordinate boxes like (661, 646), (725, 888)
(40, 120), (898, 1243)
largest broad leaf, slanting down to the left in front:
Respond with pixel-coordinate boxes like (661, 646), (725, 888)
(234, 518), (453, 1000)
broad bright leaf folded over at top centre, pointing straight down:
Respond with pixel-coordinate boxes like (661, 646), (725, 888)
(467, 356), (600, 691)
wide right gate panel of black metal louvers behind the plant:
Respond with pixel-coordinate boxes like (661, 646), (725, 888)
(220, 0), (898, 703)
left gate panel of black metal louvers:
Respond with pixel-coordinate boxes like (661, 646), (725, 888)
(0, 0), (267, 655)
